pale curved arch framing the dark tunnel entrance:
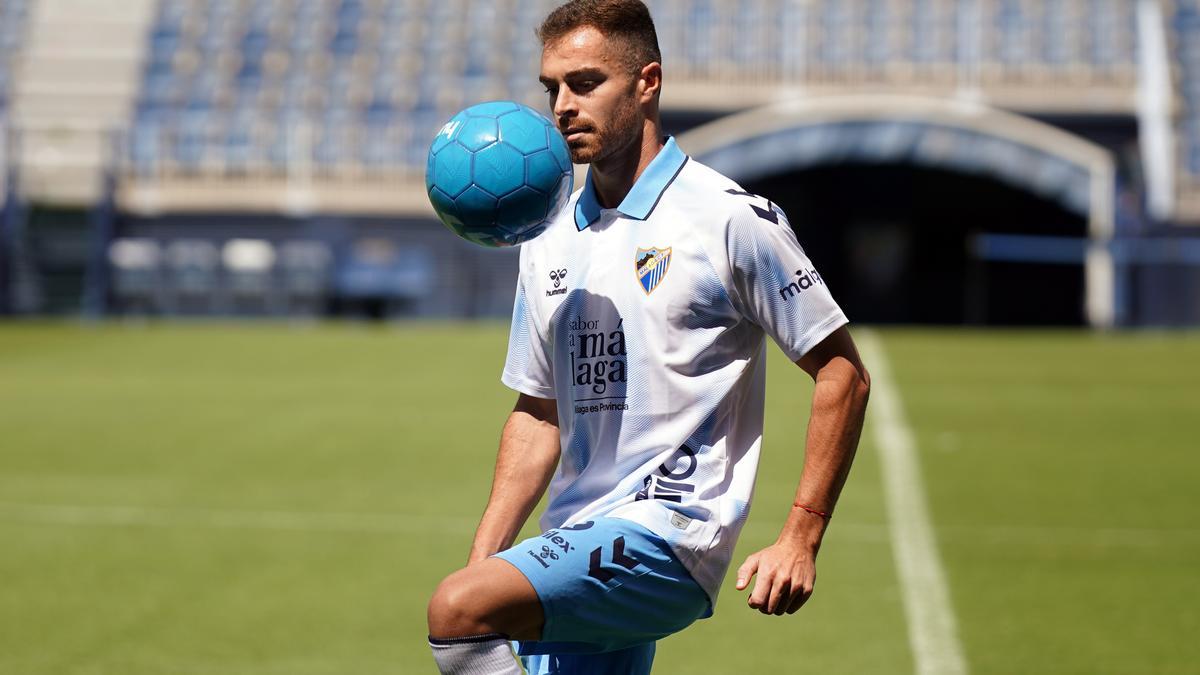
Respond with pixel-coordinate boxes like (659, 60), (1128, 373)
(678, 95), (1116, 328)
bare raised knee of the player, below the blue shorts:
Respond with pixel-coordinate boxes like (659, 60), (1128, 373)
(427, 560), (542, 639)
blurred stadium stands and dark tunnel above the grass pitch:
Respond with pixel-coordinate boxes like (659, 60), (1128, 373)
(0, 0), (1200, 328)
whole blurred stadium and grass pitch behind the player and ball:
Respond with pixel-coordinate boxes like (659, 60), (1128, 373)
(0, 0), (1200, 675)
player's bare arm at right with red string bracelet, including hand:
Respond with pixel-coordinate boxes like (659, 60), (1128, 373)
(737, 327), (871, 615)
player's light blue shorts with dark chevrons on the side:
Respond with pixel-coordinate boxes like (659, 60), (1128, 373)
(496, 518), (712, 673)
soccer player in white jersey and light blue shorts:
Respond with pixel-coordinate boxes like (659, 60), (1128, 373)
(428, 0), (870, 674)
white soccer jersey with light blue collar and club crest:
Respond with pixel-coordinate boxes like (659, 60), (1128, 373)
(502, 139), (846, 604)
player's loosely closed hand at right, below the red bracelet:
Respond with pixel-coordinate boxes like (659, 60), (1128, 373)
(737, 540), (817, 616)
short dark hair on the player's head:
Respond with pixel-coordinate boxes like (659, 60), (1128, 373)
(538, 0), (662, 72)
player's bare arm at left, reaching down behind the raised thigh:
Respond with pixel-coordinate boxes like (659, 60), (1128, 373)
(467, 394), (560, 565)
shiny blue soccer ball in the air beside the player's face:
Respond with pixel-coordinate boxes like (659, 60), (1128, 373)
(425, 101), (575, 246)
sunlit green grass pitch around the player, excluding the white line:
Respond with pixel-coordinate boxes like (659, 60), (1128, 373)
(0, 323), (1200, 675)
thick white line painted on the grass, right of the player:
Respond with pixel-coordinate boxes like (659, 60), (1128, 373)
(857, 331), (967, 675)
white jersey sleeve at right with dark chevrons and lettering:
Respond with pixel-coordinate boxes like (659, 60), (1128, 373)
(726, 195), (847, 362)
